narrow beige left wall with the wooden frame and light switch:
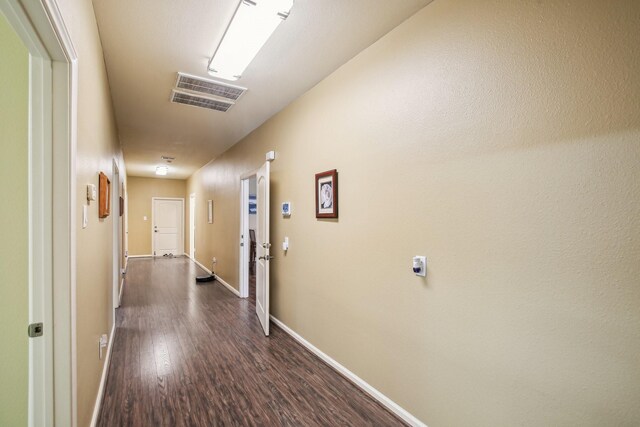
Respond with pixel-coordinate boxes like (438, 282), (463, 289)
(57, 0), (126, 426)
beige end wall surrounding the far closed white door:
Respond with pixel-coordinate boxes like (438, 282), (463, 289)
(127, 176), (189, 255)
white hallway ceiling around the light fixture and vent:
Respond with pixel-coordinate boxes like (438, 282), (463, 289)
(93, 0), (431, 178)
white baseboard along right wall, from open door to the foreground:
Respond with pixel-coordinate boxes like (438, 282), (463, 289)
(269, 315), (427, 427)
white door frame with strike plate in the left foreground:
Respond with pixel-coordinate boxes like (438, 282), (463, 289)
(0, 0), (78, 427)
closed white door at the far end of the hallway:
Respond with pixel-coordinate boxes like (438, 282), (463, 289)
(153, 198), (183, 256)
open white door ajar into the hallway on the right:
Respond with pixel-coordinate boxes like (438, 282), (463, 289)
(256, 162), (271, 335)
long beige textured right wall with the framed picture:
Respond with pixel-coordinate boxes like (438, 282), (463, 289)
(188, 0), (640, 427)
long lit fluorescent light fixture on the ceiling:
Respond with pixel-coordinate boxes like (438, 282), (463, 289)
(208, 0), (293, 80)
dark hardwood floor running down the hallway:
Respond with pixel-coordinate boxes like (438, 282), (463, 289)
(98, 257), (404, 427)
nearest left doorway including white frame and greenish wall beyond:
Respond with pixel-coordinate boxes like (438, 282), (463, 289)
(0, 0), (77, 425)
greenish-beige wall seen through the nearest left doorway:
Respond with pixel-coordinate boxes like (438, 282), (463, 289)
(0, 13), (29, 426)
